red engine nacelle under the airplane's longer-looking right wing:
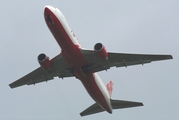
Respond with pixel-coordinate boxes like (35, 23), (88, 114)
(94, 43), (108, 59)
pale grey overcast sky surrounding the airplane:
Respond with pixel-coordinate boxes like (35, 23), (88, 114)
(0, 0), (179, 120)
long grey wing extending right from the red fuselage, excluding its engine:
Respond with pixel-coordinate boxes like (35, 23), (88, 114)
(81, 49), (173, 72)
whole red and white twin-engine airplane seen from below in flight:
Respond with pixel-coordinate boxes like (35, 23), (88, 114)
(9, 5), (173, 116)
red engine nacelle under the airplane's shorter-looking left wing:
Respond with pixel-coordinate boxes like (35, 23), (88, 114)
(38, 53), (51, 70)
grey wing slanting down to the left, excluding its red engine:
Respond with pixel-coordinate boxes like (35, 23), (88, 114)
(9, 54), (74, 88)
